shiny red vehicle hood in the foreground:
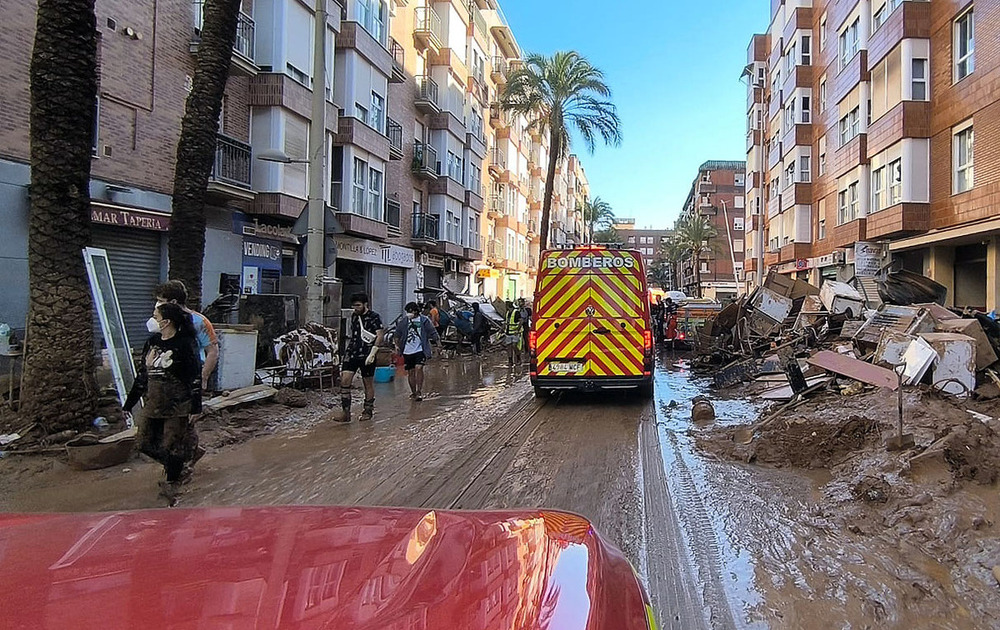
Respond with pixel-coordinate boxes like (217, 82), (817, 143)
(0, 507), (648, 630)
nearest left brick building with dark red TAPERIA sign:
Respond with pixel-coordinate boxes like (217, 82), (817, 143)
(0, 0), (262, 343)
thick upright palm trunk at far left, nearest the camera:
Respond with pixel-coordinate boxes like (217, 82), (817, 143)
(21, 0), (97, 432)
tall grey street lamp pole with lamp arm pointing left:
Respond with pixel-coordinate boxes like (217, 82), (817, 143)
(257, 0), (328, 324)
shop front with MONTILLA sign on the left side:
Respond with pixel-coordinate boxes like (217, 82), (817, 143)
(331, 234), (418, 322)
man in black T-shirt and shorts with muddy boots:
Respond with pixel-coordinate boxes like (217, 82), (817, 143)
(337, 293), (385, 423)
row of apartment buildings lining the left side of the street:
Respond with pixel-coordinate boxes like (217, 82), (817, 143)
(0, 0), (589, 339)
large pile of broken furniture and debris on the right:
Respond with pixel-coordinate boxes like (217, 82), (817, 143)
(692, 270), (1000, 408)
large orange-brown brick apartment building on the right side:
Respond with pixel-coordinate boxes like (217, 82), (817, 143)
(744, 0), (1000, 309)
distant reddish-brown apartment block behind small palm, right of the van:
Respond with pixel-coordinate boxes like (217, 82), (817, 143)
(678, 160), (746, 302)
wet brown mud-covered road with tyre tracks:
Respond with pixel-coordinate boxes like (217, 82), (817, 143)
(0, 354), (996, 629)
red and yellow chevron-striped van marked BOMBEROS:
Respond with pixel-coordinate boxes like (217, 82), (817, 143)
(528, 245), (653, 397)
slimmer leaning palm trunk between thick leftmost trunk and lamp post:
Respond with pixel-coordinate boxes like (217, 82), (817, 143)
(167, 0), (240, 309)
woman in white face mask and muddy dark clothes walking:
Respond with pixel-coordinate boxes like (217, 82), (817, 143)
(122, 303), (202, 502)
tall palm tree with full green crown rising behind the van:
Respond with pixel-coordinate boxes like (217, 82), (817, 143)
(500, 51), (621, 249)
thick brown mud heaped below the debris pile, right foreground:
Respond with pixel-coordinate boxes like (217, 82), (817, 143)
(693, 382), (1000, 628)
